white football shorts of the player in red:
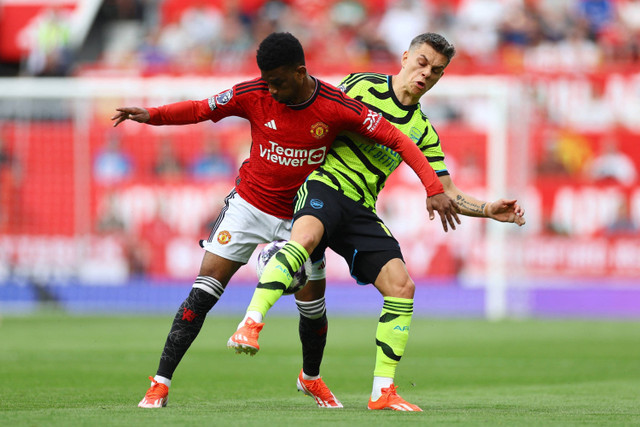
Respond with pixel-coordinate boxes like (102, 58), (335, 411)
(201, 189), (326, 280)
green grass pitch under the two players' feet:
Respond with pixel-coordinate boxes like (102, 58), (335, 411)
(0, 313), (640, 426)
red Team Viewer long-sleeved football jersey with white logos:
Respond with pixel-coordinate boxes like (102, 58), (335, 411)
(148, 78), (442, 219)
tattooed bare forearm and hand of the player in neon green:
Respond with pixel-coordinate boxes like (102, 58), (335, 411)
(439, 175), (526, 226)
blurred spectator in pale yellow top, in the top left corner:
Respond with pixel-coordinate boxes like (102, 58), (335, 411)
(22, 7), (73, 76)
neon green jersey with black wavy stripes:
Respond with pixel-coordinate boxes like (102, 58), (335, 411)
(308, 73), (449, 216)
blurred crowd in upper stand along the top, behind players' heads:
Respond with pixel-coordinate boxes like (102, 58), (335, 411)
(22, 0), (640, 74)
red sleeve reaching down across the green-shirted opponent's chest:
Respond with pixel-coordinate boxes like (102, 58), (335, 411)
(342, 103), (444, 196)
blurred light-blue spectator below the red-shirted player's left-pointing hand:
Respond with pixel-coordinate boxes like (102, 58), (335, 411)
(93, 132), (133, 185)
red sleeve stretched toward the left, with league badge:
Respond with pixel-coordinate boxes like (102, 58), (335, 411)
(147, 85), (247, 126)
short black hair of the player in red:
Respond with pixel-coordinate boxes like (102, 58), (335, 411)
(256, 33), (305, 71)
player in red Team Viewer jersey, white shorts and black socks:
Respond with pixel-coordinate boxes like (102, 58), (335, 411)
(112, 33), (459, 408)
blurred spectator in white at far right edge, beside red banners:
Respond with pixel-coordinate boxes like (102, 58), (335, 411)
(589, 137), (637, 185)
